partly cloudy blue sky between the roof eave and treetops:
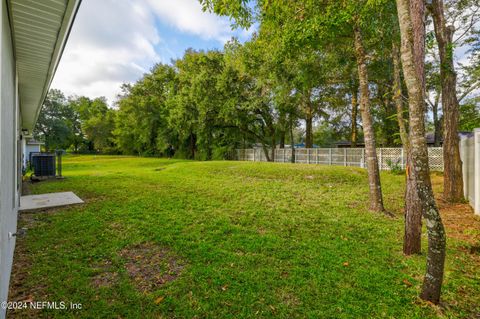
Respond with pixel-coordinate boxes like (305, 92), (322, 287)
(52, 0), (252, 103)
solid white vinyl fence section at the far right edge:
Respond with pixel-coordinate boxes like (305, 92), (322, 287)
(460, 128), (480, 215)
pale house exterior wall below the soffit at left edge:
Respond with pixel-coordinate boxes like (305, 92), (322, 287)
(0, 1), (21, 318)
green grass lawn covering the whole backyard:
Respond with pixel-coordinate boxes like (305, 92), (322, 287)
(11, 156), (480, 318)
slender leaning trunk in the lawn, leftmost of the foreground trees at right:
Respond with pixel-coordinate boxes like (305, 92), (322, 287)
(354, 27), (385, 212)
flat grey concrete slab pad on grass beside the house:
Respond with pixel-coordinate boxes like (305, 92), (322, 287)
(19, 192), (83, 211)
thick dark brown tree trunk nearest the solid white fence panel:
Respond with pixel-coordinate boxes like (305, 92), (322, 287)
(429, 0), (464, 202)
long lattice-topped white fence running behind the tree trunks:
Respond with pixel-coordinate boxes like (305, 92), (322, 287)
(236, 147), (443, 171)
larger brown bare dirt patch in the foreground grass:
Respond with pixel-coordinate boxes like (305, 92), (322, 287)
(120, 243), (185, 293)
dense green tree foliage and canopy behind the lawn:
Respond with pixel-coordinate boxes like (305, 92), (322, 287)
(32, 0), (480, 160)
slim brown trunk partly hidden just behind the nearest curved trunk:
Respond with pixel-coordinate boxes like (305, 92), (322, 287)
(392, 42), (422, 256)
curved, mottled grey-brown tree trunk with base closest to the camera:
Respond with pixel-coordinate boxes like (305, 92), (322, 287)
(397, 0), (446, 304)
